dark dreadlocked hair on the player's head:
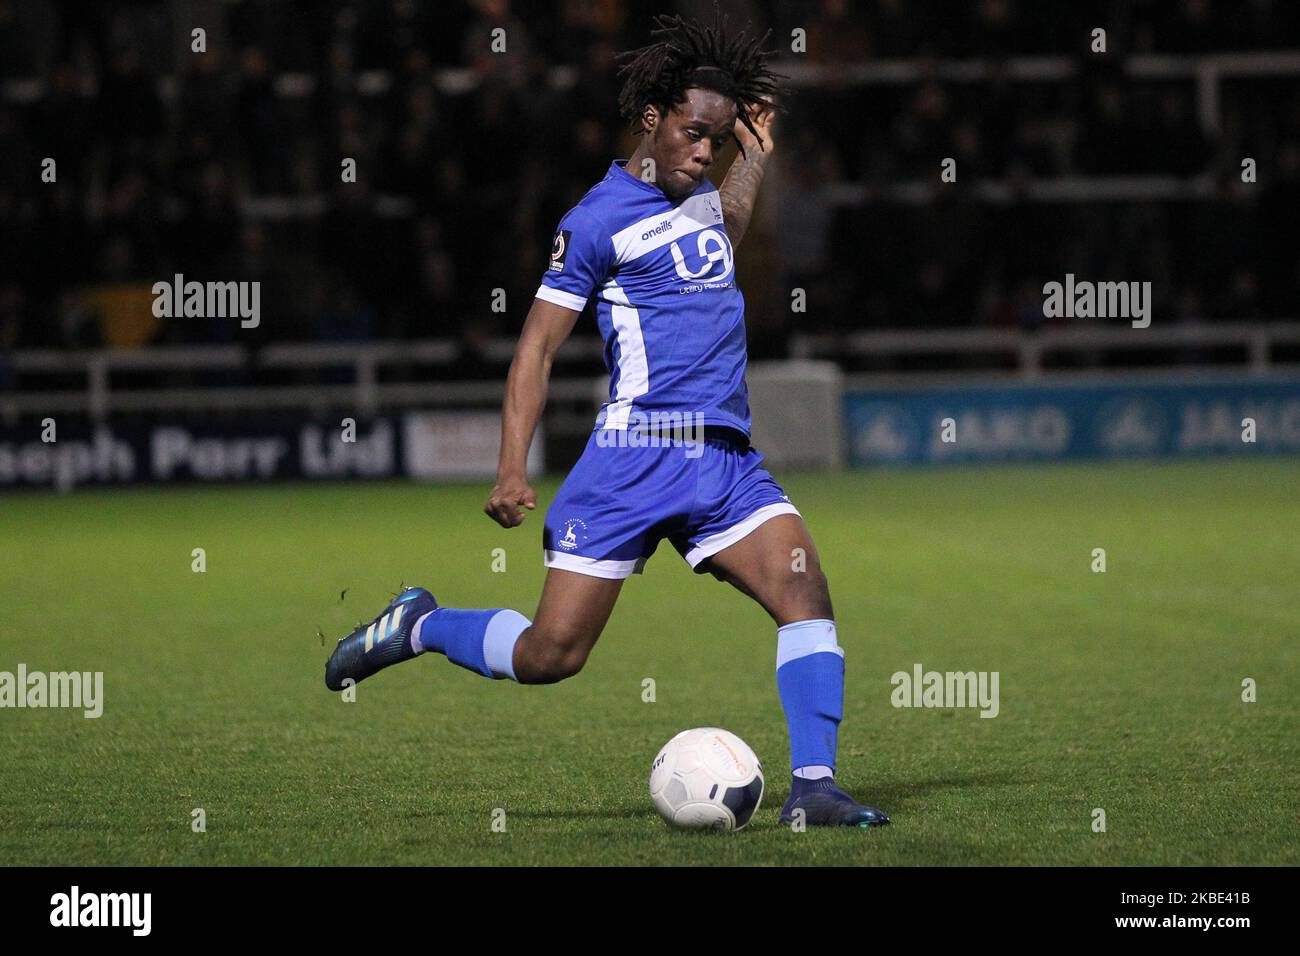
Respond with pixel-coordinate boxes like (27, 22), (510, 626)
(618, 4), (787, 155)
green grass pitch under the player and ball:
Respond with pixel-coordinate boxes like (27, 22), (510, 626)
(0, 459), (1300, 865)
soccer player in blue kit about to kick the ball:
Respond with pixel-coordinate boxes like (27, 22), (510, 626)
(325, 9), (889, 827)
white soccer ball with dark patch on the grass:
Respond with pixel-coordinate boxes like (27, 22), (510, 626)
(650, 727), (763, 830)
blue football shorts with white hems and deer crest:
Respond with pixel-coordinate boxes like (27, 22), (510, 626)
(542, 429), (798, 578)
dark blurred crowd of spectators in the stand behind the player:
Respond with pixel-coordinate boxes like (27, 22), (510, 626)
(0, 0), (1300, 354)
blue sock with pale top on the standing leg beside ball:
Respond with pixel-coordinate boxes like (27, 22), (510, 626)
(776, 619), (844, 777)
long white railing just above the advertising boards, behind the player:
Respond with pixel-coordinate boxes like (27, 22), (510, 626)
(0, 321), (1300, 420)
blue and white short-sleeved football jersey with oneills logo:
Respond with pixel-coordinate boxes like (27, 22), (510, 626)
(537, 160), (750, 434)
